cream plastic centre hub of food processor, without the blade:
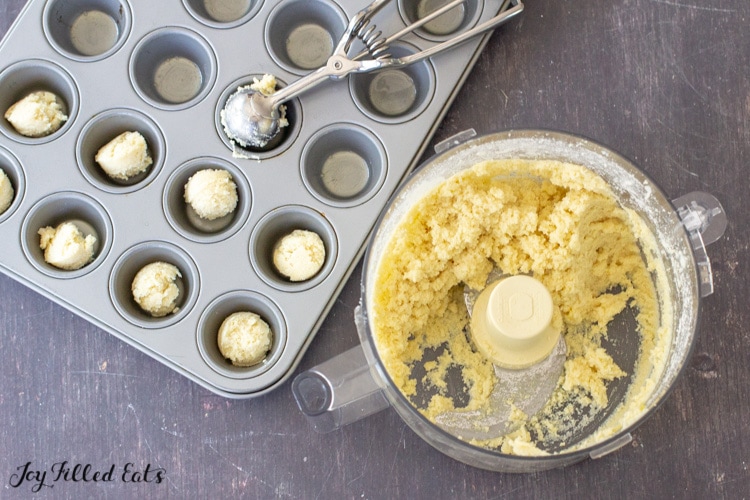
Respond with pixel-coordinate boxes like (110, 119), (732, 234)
(471, 275), (560, 369)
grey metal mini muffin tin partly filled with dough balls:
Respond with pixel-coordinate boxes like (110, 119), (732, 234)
(0, 0), (516, 398)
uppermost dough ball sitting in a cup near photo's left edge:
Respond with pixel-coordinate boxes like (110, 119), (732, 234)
(5, 90), (68, 137)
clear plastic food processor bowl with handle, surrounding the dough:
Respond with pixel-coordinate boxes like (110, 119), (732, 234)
(292, 130), (727, 472)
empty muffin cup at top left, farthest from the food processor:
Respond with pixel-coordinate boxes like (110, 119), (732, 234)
(43, 0), (133, 61)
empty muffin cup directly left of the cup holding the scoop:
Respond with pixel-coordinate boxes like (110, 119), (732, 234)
(130, 27), (217, 110)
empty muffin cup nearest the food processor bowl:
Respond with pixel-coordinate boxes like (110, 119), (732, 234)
(300, 123), (388, 207)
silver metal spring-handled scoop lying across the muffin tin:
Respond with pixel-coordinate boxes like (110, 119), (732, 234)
(222, 0), (523, 150)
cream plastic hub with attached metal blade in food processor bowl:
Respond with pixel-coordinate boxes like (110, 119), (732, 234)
(436, 273), (567, 441)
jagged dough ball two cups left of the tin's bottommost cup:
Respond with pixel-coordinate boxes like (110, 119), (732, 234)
(38, 222), (96, 271)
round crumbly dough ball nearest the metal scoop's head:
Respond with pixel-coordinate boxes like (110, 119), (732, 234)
(184, 169), (238, 220)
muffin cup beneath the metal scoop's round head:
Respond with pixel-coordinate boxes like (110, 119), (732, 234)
(214, 74), (302, 160)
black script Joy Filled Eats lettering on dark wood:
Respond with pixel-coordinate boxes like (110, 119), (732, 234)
(8, 460), (167, 493)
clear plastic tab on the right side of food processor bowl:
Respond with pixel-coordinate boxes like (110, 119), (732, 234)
(672, 191), (727, 297)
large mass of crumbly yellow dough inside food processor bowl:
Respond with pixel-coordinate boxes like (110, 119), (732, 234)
(368, 160), (670, 455)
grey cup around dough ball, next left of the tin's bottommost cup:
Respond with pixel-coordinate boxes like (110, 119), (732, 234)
(109, 241), (200, 329)
